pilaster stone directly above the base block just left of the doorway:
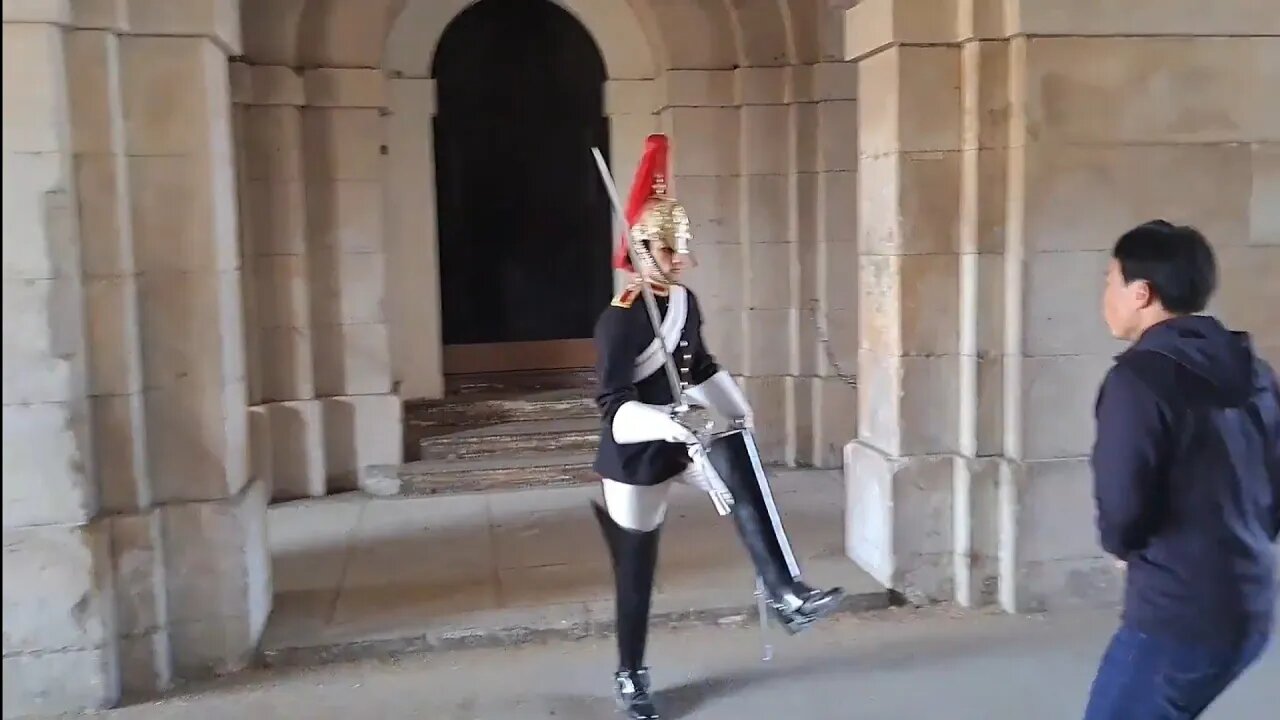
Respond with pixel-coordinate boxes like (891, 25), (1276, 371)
(312, 323), (392, 396)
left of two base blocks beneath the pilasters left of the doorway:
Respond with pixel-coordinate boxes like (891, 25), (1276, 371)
(265, 400), (328, 501)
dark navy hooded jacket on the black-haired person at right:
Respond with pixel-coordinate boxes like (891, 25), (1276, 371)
(1092, 315), (1280, 646)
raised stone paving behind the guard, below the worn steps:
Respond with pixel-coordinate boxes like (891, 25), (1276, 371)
(264, 470), (887, 665)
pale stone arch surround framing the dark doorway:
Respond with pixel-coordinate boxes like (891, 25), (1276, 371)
(383, 0), (659, 400)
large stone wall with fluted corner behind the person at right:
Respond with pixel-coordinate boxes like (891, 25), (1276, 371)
(846, 0), (1280, 610)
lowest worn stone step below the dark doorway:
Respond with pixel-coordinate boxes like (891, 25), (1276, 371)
(360, 452), (598, 497)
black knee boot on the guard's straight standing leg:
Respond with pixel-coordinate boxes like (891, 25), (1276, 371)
(591, 502), (660, 720)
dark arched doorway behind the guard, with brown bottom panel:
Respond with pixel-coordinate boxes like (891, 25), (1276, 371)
(431, 0), (613, 374)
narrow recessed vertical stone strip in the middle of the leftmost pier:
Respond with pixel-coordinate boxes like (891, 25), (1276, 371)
(67, 3), (173, 698)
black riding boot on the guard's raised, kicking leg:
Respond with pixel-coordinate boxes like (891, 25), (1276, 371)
(712, 443), (845, 634)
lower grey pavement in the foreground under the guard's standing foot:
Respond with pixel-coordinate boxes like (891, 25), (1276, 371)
(87, 609), (1280, 720)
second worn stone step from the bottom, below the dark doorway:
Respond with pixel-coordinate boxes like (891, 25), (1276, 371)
(420, 415), (600, 460)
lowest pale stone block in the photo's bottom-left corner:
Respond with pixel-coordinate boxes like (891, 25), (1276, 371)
(3, 647), (120, 720)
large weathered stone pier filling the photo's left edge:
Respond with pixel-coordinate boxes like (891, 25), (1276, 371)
(4, 0), (271, 716)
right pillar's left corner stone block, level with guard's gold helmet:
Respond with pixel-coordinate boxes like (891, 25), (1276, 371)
(858, 152), (961, 255)
